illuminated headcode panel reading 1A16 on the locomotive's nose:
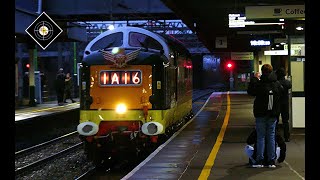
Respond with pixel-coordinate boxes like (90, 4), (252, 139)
(99, 70), (142, 86)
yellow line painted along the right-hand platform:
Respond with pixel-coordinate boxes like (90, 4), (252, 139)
(198, 91), (230, 180)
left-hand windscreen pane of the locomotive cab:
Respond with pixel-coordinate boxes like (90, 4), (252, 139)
(90, 32), (123, 51)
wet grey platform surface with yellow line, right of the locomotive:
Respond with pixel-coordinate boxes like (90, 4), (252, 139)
(122, 92), (305, 180)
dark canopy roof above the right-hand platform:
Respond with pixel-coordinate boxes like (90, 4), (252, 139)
(161, 0), (305, 51)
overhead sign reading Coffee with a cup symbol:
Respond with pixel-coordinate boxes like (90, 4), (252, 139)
(245, 5), (305, 19)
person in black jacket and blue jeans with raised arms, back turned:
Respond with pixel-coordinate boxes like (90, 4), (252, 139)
(247, 64), (283, 168)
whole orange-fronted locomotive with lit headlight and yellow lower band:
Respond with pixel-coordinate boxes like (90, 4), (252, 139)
(77, 27), (192, 163)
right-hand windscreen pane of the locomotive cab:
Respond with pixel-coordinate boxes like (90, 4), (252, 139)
(129, 32), (163, 50)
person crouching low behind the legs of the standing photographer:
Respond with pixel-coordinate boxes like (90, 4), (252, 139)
(245, 129), (287, 165)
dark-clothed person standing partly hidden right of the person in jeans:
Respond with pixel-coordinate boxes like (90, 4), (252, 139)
(276, 68), (292, 142)
